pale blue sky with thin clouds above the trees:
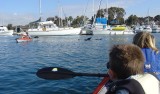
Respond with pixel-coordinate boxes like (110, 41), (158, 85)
(0, 0), (160, 26)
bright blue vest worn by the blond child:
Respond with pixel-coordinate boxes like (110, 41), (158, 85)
(142, 48), (160, 79)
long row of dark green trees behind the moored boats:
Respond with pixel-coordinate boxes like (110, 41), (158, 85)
(47, 7), (160, 27)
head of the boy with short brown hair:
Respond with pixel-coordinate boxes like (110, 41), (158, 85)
(108, 44), (144, 79)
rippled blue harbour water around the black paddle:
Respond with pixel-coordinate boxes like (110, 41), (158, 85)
(0, 34), (160, 94)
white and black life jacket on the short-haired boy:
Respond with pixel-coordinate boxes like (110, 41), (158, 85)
(106, 73), (160, 94)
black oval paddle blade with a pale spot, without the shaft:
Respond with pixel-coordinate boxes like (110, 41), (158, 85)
(36, 67), (75, 80)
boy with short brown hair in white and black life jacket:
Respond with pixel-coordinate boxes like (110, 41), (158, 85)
(105, 44), (160, 94)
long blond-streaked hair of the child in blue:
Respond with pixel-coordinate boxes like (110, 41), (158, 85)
(133, 32), (158, 52)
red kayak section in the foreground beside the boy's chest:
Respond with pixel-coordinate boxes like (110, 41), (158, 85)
(93, 77), (110, 94)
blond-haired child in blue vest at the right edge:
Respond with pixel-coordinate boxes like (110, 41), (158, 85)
(133, 32), (160, 79)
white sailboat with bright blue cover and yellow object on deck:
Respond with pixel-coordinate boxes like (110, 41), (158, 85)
(81, 0), (134, 35)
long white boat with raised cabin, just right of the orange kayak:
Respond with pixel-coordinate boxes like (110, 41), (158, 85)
(27, 21), (81, 36)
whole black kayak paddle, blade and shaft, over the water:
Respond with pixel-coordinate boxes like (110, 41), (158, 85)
(36, 67), (108, 80)
